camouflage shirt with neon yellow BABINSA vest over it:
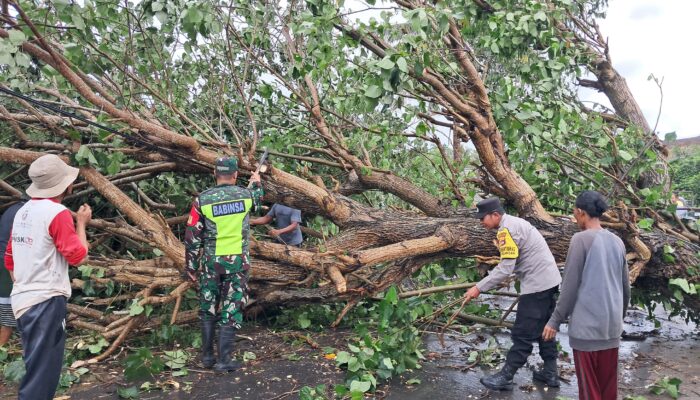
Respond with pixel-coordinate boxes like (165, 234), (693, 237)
(185, 183), (263, 273)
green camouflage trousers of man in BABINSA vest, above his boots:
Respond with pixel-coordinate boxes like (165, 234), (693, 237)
(199, 257), (250, 329)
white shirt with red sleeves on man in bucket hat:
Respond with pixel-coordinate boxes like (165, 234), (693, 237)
(5, 199), (87, 318)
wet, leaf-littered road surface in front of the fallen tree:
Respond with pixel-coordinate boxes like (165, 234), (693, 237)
(0, 304), (700, 400)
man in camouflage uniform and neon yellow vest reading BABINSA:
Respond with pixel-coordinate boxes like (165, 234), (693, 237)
(185, 157), (263, 372)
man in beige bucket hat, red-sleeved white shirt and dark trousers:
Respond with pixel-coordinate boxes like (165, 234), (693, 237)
(5, 154), (92, 400)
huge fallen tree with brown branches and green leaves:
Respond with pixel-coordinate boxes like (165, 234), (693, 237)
(0, 1), (700, 362)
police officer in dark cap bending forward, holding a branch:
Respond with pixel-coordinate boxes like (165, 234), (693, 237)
(464, 198), (561, 390)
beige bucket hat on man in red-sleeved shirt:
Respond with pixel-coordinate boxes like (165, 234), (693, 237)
(27, 154), (80, 199)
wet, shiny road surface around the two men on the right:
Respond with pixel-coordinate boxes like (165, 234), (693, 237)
(387, 302), (700, 400)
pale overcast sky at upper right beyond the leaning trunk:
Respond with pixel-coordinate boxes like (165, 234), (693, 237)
(582, 0), (700, 138)
